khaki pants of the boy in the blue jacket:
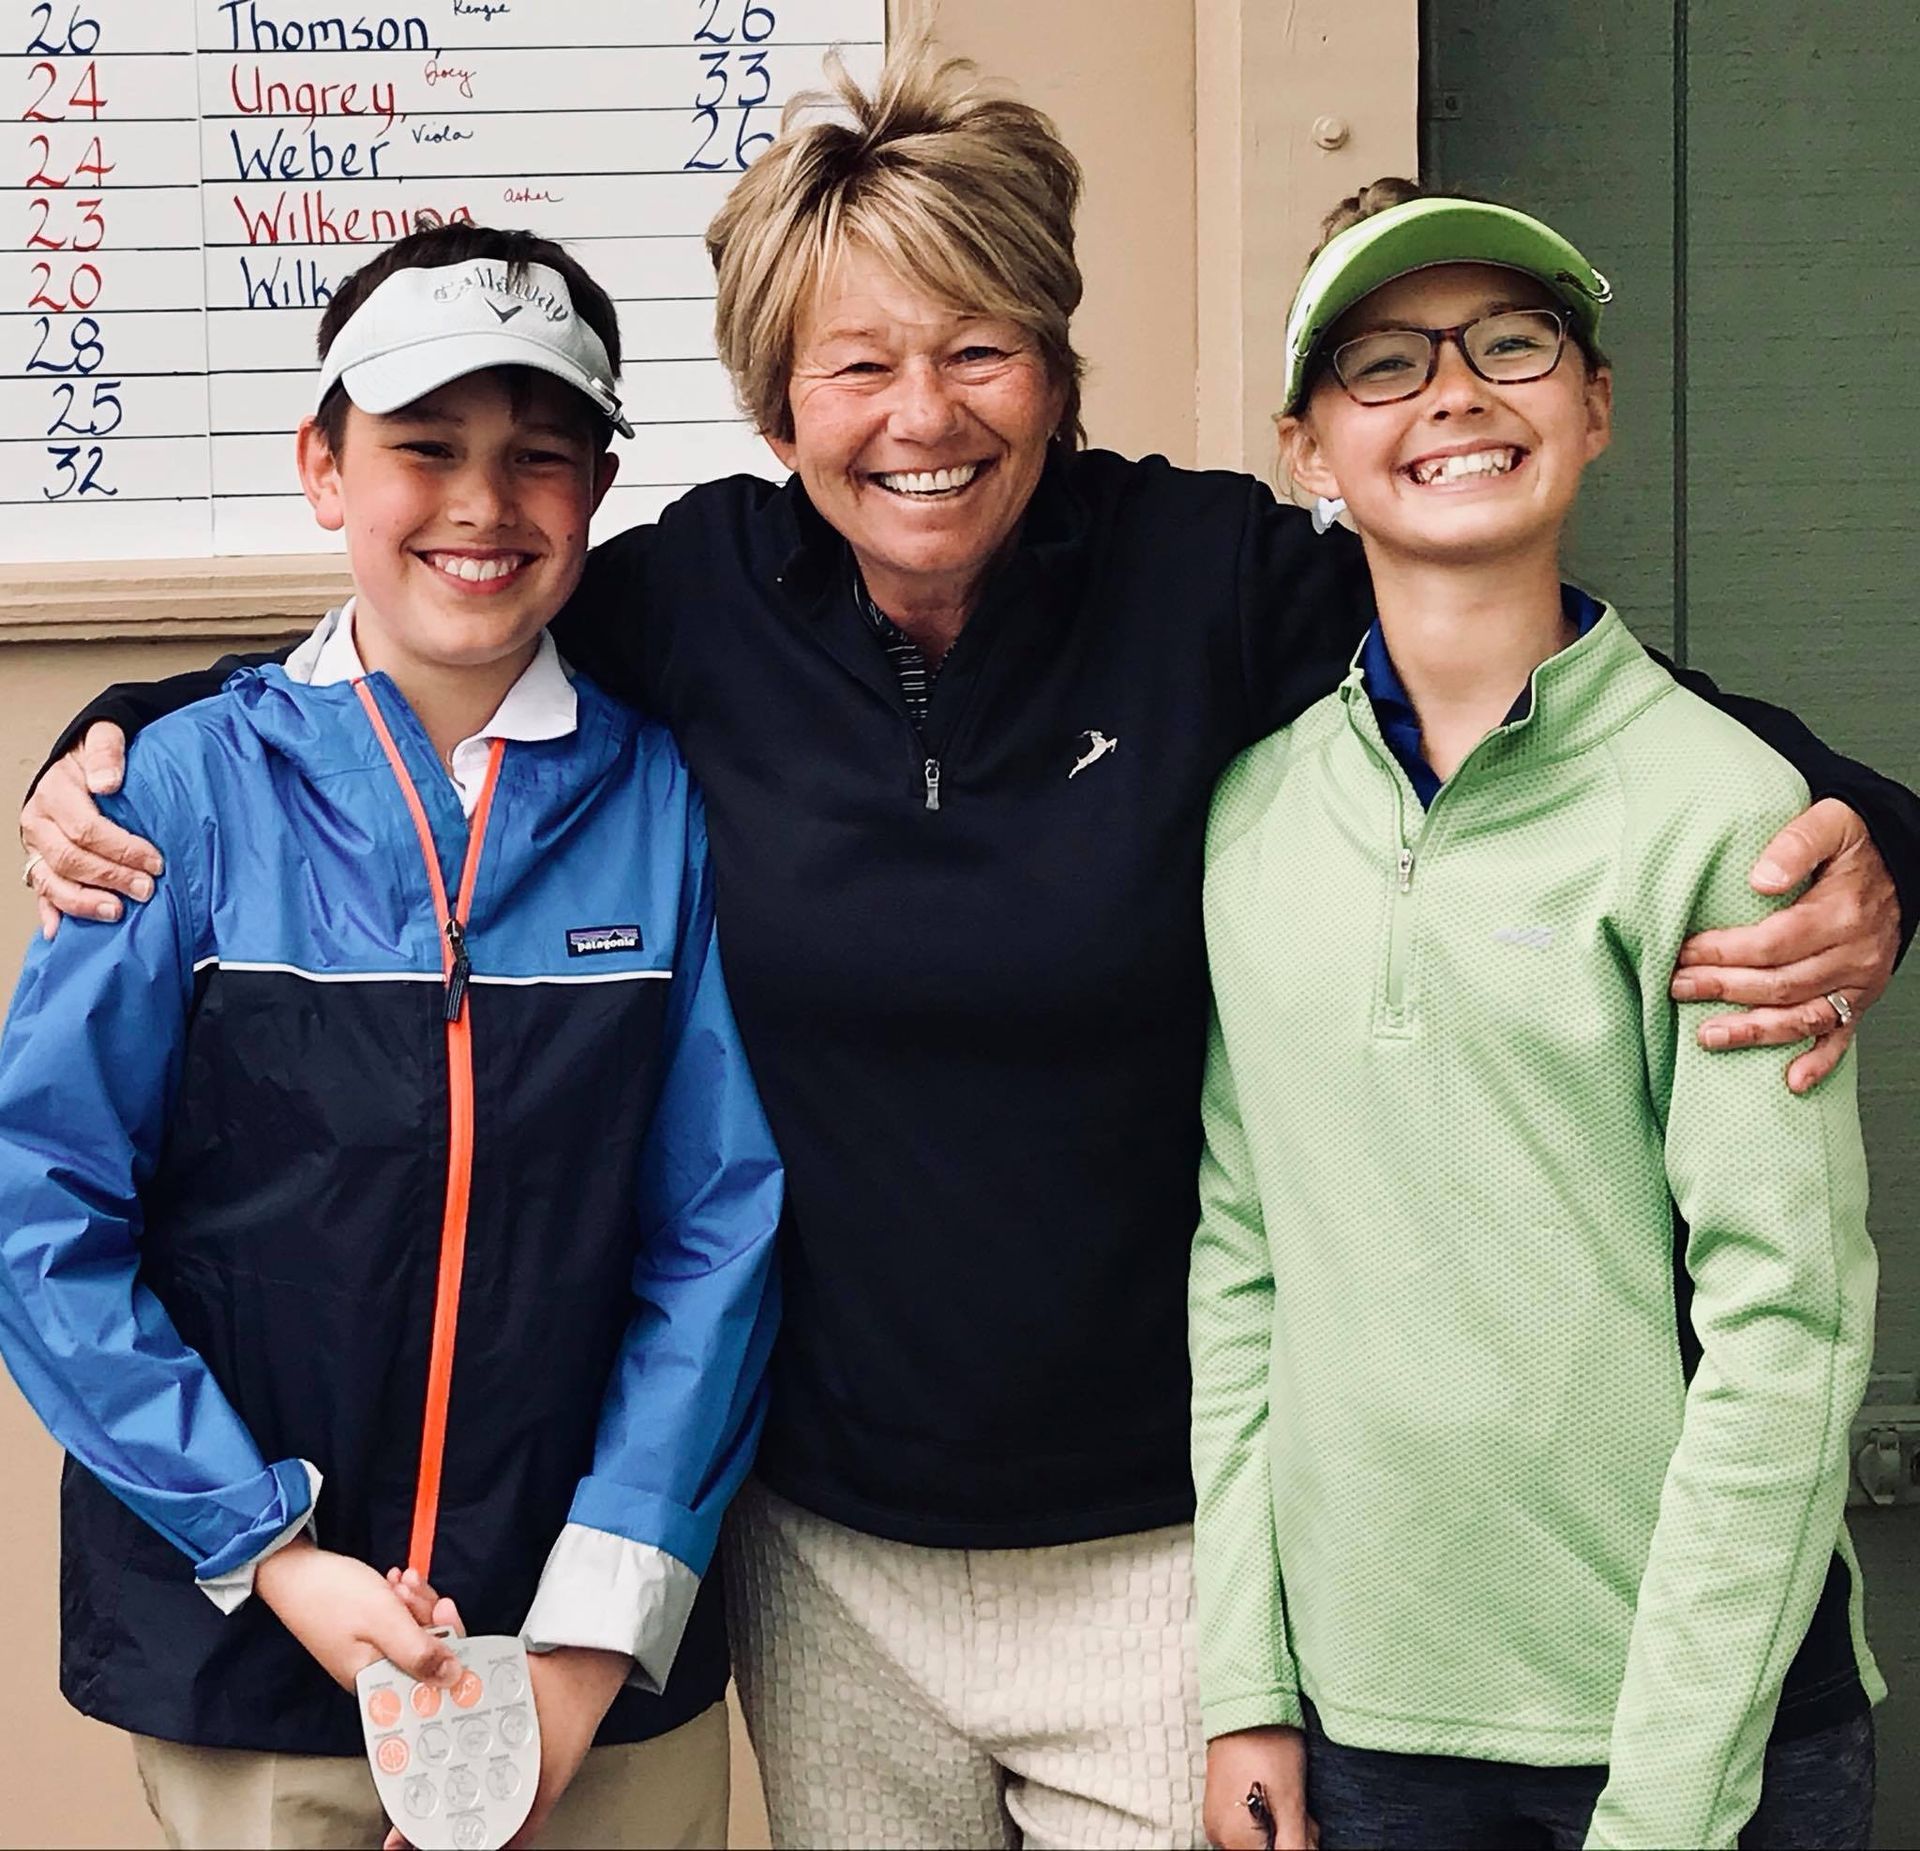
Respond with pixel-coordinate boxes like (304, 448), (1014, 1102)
(132, 1703), (728, 1851)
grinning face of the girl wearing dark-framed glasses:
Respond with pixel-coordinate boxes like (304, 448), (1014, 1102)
(1288, 263), (1613, 563)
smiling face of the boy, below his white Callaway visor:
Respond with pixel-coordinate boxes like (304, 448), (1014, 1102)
(300, 373), (616, 668)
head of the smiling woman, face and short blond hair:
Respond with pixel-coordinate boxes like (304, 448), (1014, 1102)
(707, 60), (1083, 666)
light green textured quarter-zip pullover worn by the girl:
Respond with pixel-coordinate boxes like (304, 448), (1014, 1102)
(1190, 611), (1885, 1845)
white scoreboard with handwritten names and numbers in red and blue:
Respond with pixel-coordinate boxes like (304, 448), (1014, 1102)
(0, 0), (885, 563)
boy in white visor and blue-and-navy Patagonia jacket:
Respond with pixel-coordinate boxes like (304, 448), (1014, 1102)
(0, 227), (781, 1845)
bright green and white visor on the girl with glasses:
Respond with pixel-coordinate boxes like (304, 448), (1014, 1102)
(1284, 200), (1613, 411)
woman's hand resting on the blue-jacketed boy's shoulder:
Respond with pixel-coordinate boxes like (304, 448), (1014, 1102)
(19, 720), (163, 939)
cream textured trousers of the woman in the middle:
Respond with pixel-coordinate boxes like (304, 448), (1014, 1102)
(722, 1484), (1206, 1851)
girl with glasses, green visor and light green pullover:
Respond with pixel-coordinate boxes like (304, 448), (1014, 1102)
(1190, 182), (1884, 1851)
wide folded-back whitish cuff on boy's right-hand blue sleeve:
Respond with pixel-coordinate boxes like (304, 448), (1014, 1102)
(520, 1523), (701, 1695)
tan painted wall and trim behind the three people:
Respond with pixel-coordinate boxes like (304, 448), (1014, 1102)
(0, 0), (1417, 1845)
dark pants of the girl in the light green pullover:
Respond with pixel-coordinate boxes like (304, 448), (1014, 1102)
(1308, 1709), (1874, 1851)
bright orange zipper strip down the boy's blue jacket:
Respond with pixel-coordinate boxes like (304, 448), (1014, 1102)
(353, 682), (507, 1580)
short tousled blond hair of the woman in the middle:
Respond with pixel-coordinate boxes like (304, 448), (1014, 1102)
(707, 42), (1085, 444)
